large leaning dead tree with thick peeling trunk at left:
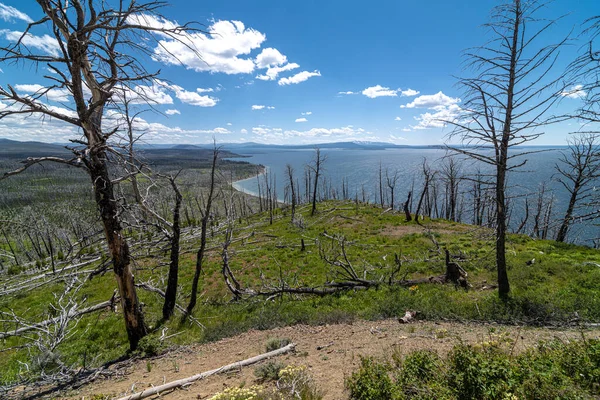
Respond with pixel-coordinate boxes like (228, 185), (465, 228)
(0, 0), (204, 349)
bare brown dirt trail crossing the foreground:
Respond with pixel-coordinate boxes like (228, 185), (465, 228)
(65, 320), (600, 400)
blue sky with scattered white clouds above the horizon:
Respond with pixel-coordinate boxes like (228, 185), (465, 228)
(0, 0), (600, 145)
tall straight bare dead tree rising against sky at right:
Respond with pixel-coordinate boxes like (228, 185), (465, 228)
(446, 0), (567, 298)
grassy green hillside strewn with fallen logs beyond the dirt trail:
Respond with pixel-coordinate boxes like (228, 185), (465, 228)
(0, 202), (600, 384)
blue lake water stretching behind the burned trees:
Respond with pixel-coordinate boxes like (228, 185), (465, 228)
(229, 147), (598, 245)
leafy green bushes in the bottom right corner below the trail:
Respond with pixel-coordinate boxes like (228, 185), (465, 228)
(346, 340), (600, 400)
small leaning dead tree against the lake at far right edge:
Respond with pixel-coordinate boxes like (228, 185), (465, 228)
(555, 133), (600, 242)
